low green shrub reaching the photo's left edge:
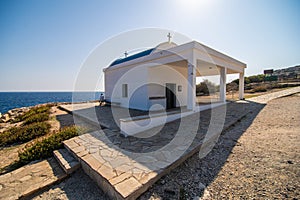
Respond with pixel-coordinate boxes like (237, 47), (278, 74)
(0, 122), (50, 146)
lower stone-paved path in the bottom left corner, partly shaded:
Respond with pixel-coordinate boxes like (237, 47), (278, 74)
(0, 158), (67, 200)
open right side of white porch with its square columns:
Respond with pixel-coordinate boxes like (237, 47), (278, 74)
(187, 43), (246, 111)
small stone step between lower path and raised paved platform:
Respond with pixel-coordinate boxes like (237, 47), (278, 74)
(53, 149), (80, 174)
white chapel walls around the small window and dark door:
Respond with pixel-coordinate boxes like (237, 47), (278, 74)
(105, 61), (188, 110)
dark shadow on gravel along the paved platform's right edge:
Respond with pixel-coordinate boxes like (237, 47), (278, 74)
(139, 101), (265, 200)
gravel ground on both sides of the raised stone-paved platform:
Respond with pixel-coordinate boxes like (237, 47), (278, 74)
(34, 94), (300, 200)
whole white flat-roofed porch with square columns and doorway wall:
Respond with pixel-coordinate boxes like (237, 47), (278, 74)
(148, 41), (246, 111)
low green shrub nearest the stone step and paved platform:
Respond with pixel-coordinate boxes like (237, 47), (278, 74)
(19, 126), (81, 162)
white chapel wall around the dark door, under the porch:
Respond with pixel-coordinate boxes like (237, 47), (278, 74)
(148, 65), (188, 107)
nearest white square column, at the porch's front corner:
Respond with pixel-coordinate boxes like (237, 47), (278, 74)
(187, 61), (197, 110)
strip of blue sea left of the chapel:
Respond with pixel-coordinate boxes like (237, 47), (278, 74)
(0, 92), (104, 114)
